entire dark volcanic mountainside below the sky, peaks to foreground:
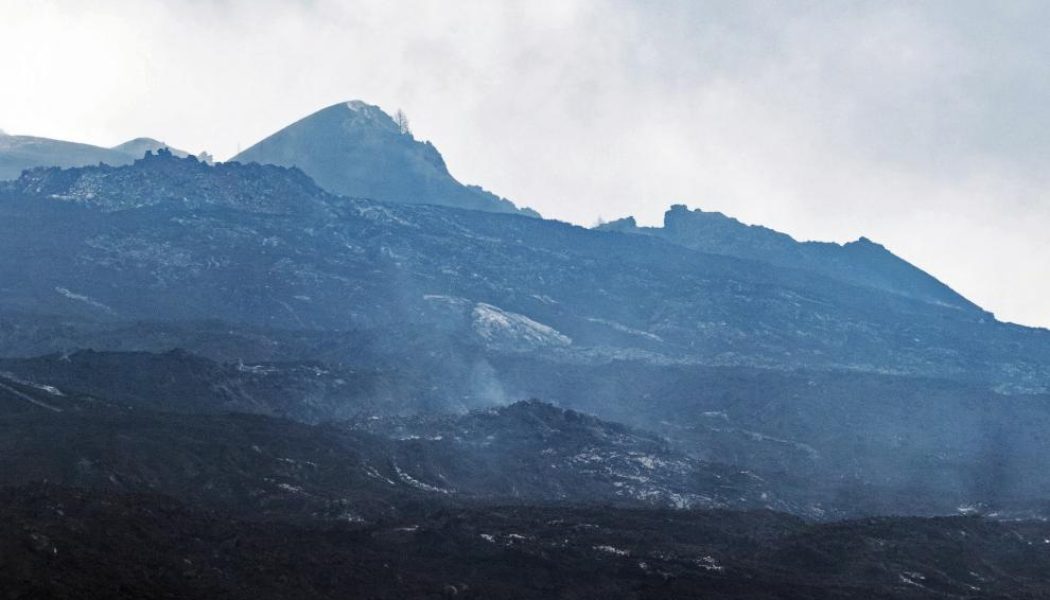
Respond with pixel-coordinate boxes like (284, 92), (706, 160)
(0, 102), (1050, 598)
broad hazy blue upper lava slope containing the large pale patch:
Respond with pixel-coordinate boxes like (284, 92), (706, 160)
(0, 152), (1050, 390)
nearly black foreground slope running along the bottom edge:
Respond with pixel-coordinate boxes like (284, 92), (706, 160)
(6, 485), (1050, 600)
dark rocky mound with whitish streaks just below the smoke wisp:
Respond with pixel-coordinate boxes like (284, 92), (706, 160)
(344, 400), (810, 516)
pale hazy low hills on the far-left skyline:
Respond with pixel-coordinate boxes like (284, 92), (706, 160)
(0, 131), (193, 181)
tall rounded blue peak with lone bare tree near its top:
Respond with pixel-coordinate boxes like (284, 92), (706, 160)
(231, 100), (536, 215)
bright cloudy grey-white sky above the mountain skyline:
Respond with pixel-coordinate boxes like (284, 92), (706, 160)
(0, 0), (1050, 327)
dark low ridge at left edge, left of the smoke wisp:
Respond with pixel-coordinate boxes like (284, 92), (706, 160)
(0, 350), (380, 423)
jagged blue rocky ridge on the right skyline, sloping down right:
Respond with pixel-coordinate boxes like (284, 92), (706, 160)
(599, 205), (980, 311)
